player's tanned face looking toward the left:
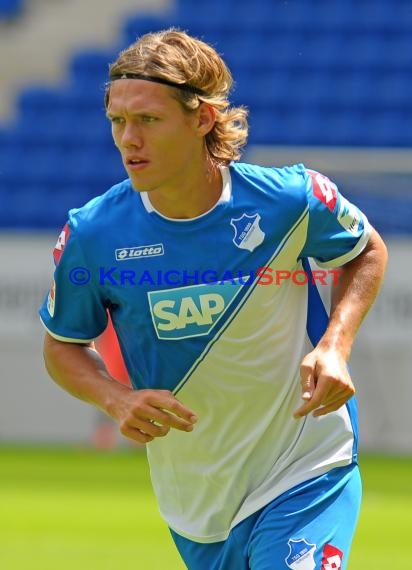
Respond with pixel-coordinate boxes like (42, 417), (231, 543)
(107, 79), (210, 192)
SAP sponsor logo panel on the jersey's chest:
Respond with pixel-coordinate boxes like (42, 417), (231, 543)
(147, 279), (242, 340)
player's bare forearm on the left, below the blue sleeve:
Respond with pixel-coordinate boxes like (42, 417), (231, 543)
(44, 328), (130, 416)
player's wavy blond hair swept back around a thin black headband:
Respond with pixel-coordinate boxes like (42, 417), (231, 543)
(105, 28), (248, 164)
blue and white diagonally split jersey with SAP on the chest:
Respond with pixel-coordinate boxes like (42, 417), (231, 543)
(40, 163), (370, 542)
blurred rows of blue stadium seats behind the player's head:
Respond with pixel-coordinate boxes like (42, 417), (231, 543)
(0, 0), (412, 232)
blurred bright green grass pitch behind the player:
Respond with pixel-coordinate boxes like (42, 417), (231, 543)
(0, 447), (412, 570)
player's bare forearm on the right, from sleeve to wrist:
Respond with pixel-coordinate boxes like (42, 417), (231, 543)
(318, 230), (387, 360)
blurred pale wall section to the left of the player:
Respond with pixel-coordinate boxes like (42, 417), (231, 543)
(0, 234), (98, 441)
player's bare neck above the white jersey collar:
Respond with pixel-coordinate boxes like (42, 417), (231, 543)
(148, 166), (223, 219)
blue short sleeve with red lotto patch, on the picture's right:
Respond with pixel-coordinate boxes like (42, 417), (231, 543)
(301, 170), (372, 267)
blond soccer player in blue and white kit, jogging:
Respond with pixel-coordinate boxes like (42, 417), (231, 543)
(40, 29), (386, 570)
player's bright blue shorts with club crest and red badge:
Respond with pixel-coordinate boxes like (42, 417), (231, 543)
(171, 464), (362, 570)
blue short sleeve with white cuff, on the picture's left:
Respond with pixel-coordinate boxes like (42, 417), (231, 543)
(39, 223), (107, 343)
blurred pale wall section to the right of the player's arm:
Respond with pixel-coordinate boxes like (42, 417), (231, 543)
(351, 239), (412, 452)
